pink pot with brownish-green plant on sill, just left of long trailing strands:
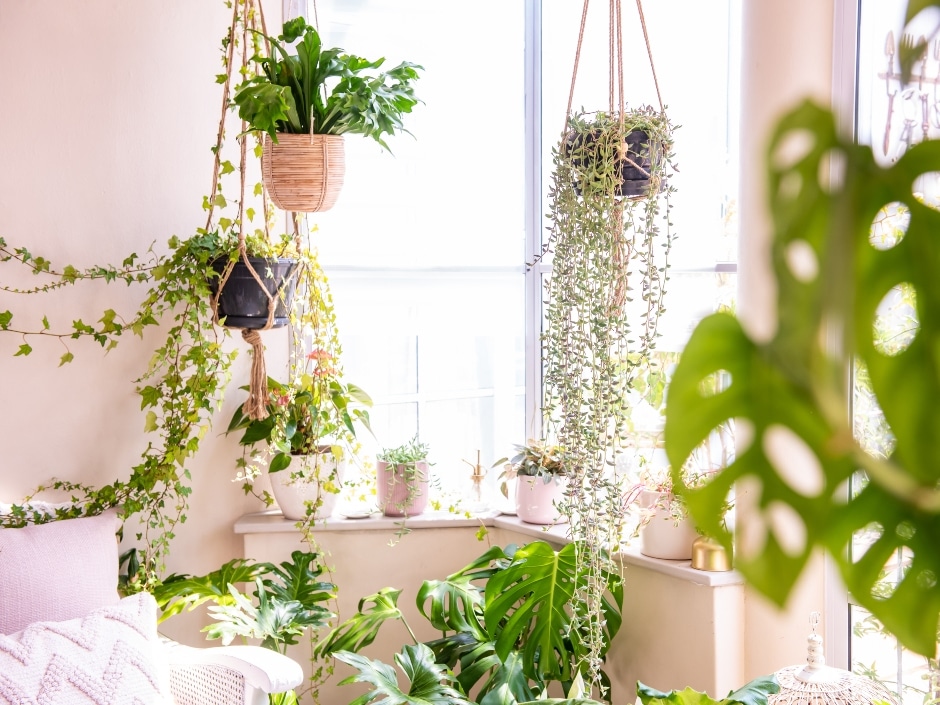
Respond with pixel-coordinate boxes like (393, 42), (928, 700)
(504, 438), (568, 525)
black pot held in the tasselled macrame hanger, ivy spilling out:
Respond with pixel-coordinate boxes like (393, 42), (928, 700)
(209, 257), (299, 330)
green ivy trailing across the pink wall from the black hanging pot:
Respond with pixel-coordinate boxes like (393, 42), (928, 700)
(0, 0), (302, 590)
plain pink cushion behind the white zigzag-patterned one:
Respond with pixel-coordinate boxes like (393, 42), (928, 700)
(0, 510), (120, 634)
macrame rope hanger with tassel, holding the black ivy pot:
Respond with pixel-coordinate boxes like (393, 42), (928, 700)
(206, 0), (300, 420)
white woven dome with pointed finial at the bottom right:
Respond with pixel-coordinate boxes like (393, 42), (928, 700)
(767, 612), (898, 705)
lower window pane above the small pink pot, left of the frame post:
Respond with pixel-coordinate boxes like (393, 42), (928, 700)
(330, 270), (525, 477)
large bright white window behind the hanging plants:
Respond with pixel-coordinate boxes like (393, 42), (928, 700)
(306, 0), (741, 506)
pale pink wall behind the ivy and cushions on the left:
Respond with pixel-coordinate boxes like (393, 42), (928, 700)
(0, 0), (284, 641)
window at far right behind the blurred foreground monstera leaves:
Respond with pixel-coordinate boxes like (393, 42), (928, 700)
(849, 0), (940, 705)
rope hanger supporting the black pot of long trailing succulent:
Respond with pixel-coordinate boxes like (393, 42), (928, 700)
(562, 0), (666, 311)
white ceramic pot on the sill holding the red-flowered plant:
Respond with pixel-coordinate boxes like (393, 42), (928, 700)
(268, 452), (346, 521)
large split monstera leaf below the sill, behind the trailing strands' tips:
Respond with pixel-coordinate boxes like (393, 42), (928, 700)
(485, 541), (623, 682)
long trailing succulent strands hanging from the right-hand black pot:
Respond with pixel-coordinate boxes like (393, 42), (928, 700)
(542, 107), (674, 683)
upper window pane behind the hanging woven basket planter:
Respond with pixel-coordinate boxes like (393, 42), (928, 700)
(313, 0), (525, 267)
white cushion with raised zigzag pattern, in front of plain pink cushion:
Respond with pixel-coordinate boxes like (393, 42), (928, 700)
(0, 593), (172, 705)
